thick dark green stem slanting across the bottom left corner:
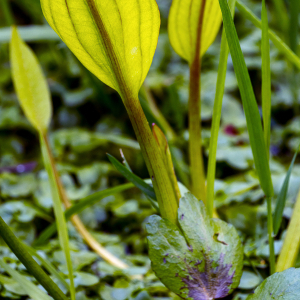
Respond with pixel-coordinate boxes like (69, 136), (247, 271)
(0, 217), (68, 300)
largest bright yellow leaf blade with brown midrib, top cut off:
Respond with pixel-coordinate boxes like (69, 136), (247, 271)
(41, 0), (160, 95)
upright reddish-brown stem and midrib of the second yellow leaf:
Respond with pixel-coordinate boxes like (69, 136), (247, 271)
(188, 0), (206, 203)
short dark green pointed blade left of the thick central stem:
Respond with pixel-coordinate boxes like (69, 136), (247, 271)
(107, 154), (156, 199)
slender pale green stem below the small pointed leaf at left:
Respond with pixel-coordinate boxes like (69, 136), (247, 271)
(40, 132), (76, 300)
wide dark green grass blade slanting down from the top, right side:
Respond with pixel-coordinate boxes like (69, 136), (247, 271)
(219, 0), (273, 197)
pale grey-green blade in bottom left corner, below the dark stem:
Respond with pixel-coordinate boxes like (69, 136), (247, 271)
(0, 259), (52, 300)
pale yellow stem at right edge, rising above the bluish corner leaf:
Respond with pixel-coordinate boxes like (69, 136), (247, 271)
(276, 191), (300, 272)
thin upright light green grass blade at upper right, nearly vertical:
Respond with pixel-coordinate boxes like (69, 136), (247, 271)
(261, 0), (271, 157)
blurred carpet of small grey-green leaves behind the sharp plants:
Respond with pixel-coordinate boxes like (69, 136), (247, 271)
(0, 0), (300, 300)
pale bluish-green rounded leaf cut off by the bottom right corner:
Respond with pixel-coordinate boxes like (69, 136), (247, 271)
(247, 268), (300, 300)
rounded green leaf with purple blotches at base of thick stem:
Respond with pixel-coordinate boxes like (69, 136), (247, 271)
(147, 194), (243, 300)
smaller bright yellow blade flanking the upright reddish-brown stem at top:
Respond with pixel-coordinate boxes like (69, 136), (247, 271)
(168, 0), (222, 63)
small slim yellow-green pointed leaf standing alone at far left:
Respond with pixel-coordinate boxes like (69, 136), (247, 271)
(10, 27), (52, 132)
